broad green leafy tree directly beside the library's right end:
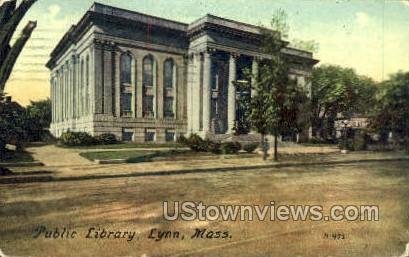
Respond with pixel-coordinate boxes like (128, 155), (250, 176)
(311, 65), (376, 139)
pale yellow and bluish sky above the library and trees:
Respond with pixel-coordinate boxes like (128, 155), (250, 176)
(0, 0), (409, 105)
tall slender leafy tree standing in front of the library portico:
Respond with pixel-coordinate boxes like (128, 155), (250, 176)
(237, 10), (307, 161)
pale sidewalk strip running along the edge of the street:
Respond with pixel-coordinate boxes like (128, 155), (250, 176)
(0, 152), (409, 184)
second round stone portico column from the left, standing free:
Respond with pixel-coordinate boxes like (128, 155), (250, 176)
(227, 54), (237, 133)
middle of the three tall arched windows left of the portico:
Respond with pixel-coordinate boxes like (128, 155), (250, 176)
(142, 55), (156, 118)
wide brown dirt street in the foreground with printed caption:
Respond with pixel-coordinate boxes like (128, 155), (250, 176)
(0, 162), (409, 257)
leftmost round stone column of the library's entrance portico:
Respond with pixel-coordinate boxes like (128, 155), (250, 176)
(203, 52), (212, 135)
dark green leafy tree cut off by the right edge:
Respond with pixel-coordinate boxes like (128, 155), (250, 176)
(370, 72), (409, 150)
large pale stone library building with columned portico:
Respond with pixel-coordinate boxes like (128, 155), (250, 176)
(47, 3), (317, 142)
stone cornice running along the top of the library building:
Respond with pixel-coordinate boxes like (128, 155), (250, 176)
(46, 3), (318, 69)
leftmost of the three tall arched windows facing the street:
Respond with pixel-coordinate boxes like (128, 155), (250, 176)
(120, 53), (133, 116)
